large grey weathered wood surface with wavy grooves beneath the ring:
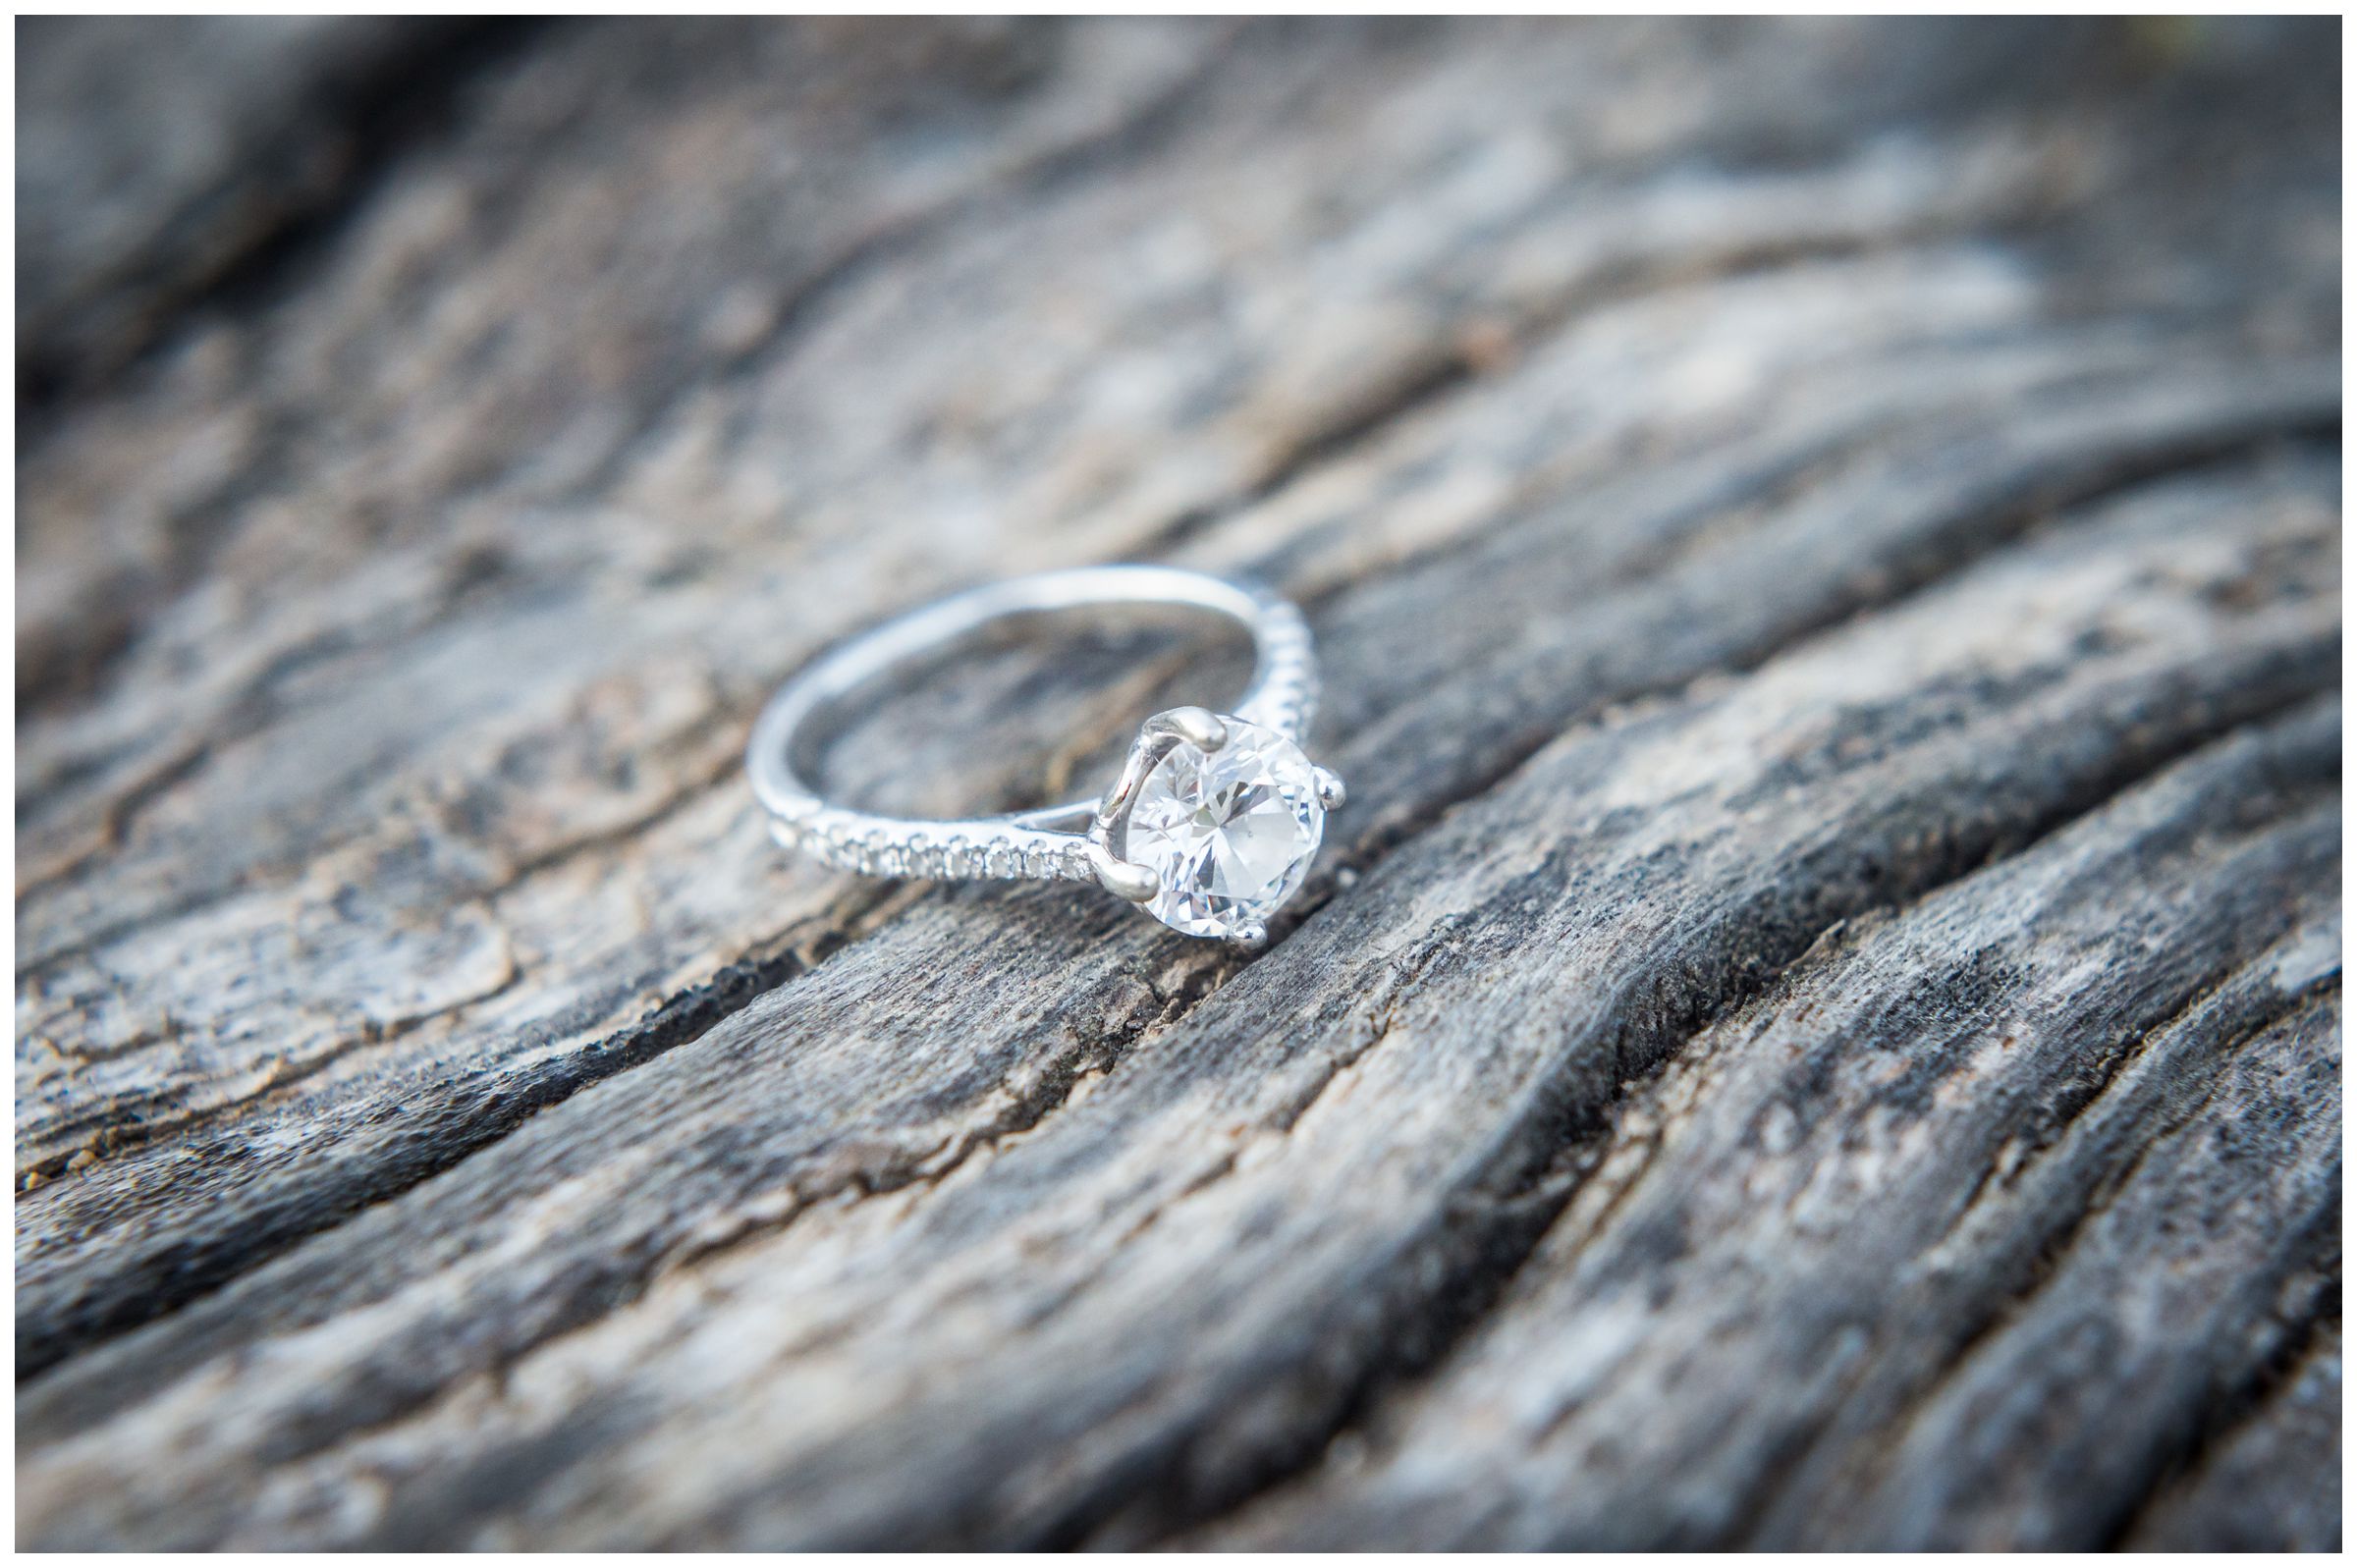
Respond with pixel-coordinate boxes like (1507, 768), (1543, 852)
(17, 22), (2340, 1546)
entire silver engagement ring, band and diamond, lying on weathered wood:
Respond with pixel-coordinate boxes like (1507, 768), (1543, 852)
(744, 566), (1343, 941)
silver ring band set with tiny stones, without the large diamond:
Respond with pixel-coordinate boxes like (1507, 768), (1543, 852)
(744, 566), (1318, 882)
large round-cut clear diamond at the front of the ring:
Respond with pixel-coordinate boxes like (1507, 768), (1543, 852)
(1115, 719), (1325, 936)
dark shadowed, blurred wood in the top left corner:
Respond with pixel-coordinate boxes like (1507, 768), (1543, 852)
(17, 17), (532, 407)
